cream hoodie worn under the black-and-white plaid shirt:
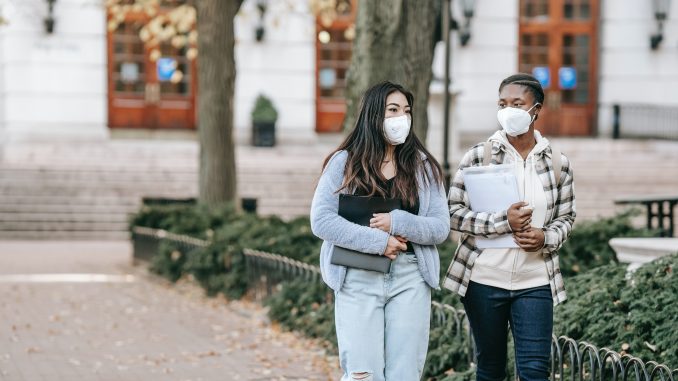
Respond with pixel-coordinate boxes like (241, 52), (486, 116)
(471, 130), (549, 290)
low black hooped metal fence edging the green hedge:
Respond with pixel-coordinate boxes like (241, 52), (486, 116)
(133, 227), (678, 381)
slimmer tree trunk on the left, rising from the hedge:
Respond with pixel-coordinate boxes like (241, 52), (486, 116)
(195, 0), (242, 205)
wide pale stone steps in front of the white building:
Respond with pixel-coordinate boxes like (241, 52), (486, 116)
(0, 139), (678, 239)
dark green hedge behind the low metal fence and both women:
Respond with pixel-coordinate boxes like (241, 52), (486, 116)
(131, 205), (678, 381)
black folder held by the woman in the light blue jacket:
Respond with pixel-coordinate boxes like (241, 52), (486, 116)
(330, 194), (401, 273)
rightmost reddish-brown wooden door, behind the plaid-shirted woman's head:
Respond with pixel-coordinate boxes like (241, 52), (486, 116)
(518, 0), (599, 136)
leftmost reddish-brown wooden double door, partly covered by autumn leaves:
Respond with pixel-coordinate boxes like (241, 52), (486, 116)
(108, 1), (197, 129)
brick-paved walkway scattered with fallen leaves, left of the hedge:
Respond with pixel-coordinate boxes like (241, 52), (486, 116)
(0, 241), (338, 381)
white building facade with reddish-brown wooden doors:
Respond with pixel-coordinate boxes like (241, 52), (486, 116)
(0, 0), (678, 152)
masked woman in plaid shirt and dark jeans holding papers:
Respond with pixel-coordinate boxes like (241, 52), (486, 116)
(443, 74), (576, 381)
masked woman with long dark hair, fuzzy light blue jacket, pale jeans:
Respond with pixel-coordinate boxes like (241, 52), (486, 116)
(311, 82), (450, 381)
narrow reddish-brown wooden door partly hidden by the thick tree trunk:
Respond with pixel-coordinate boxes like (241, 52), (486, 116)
(315, 0), (357, 132)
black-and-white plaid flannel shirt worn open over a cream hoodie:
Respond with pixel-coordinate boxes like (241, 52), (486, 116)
(443, 141), (576, 304)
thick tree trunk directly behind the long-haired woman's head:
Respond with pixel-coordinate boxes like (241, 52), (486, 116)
(344, 0), (439, 142)
